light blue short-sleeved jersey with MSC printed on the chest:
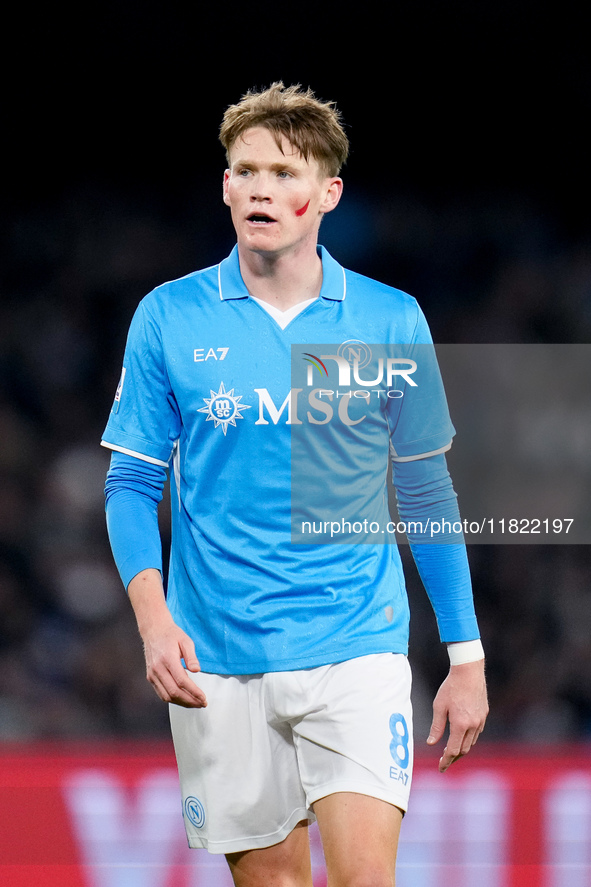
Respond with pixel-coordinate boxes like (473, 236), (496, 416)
(103, 248), (462, 674)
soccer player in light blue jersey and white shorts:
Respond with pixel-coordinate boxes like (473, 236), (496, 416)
(103, 83), (488, 887)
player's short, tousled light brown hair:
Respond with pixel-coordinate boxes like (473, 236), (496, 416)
(220, 81), (349, 176)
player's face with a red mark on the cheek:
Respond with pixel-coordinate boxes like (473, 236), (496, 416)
(224, 127), (342, 255)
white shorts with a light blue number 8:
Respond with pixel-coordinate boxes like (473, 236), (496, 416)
(170, 653), (413, 853)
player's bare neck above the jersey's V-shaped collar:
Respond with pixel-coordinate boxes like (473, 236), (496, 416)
(238, 244), (322, 311)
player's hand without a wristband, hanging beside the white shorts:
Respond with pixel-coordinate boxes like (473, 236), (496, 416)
(143, 620), (207, 708)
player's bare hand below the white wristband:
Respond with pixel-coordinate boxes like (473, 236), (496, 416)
(427, 659), (488, 773)
